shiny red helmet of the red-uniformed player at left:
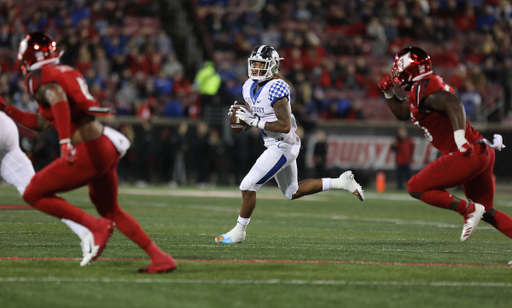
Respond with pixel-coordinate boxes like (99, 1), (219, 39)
(18, 32), (60, 74)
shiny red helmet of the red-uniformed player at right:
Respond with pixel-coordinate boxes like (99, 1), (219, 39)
(391, 47), (432, 90)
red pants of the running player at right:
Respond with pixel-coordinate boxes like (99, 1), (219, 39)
(407, 143), (512, 238)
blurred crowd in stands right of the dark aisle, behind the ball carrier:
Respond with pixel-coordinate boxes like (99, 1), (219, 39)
(196, 0), (512, 121)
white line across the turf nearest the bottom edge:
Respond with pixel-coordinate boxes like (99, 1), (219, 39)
(0, 277), (512, 288)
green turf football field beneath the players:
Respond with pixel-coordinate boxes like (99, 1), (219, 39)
(0, 185), (512, 308)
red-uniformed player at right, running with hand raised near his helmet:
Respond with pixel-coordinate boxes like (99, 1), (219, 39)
(379, 47), (512, 241)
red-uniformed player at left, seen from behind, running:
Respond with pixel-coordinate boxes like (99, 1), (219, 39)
(0, 32), (176, 273)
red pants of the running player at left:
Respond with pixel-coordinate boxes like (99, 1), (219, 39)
(23, 136), (152, 249)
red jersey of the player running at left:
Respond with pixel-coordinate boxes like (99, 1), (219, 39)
(25, 65), (111, 136)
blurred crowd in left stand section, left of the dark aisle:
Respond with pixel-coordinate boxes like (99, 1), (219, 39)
(0, 0), (193, 119)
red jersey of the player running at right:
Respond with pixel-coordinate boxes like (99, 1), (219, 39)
(409, 74), (482, 155)
